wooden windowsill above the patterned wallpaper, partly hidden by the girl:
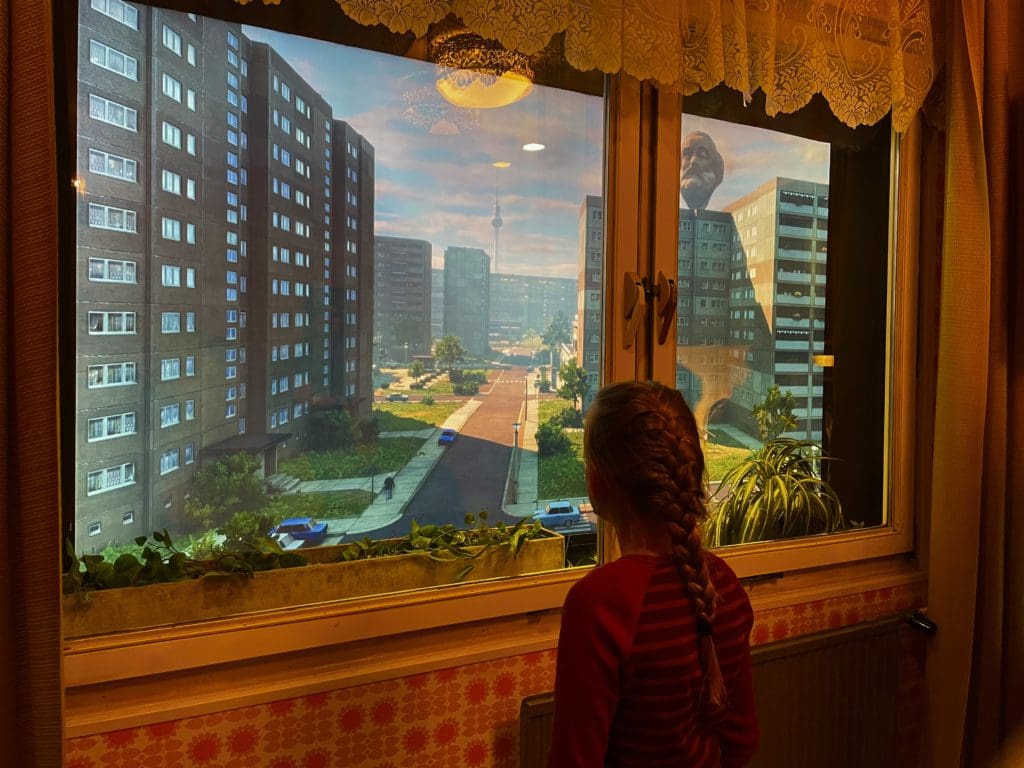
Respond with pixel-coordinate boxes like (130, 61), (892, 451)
(63, 556), (926, 737)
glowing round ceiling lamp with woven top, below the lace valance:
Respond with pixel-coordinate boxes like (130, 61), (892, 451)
(427, 28), (534, 110)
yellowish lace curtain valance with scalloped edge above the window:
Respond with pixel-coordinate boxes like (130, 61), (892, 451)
(236, 0), (935, 130)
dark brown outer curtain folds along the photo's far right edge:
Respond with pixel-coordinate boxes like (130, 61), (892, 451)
(964, 0), (1024, 766)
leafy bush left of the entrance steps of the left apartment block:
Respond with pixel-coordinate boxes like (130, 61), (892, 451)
(185, 453), (268, 527)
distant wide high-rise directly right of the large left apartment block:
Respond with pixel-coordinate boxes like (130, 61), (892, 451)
(374, 237), (431, 360)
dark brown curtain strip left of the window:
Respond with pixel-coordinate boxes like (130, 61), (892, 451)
(0, 0), (62, 768)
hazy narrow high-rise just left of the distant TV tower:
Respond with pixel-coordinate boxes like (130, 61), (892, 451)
(443, 246), (490, 354)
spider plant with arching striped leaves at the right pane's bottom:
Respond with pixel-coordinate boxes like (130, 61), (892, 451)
(703, 437), (846, 547)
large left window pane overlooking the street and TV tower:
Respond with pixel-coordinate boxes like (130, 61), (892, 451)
(76, 3), (604, 610)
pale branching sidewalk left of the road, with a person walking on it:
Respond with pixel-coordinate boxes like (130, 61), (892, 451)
(291, 399), (481, 544)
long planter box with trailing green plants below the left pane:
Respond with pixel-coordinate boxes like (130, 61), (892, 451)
(63, 512), (565, 637)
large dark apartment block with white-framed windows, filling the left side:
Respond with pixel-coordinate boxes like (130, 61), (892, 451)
(76, 0), (373, 551)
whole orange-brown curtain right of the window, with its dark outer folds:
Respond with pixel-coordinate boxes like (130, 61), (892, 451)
(923, 0), (1024, 768)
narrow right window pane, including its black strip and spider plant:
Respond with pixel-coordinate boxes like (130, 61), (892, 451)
(676, 114), (887, 545)
